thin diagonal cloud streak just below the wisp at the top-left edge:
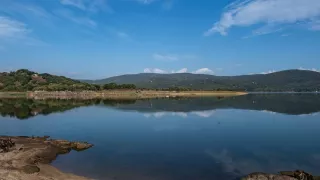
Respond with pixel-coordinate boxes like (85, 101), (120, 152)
(53, 9), (97, 28)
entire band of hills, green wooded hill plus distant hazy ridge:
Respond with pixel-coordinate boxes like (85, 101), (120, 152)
(0, 69), (320, 92)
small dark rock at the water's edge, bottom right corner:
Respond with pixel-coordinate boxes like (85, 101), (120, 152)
(242, 170), (320, 180)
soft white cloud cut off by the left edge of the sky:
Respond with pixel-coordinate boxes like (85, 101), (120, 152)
(0, 16), (31, 39)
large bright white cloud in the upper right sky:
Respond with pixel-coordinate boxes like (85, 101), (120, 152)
(205, 0), (320, 35)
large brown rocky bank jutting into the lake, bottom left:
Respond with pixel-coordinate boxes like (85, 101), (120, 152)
(0, 136), (93, 180)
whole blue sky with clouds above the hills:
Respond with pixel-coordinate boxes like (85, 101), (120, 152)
(0, 0), (320, 79)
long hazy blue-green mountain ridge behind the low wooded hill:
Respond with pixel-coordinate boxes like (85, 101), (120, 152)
(85, 70), (320, 91)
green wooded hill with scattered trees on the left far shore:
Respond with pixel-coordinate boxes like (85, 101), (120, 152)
(0, 69), (135, 91)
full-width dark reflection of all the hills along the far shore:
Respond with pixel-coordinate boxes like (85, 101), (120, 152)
(0, 94), (320, 119)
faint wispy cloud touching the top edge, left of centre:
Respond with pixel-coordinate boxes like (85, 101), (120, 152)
(60, 0), (113, 13)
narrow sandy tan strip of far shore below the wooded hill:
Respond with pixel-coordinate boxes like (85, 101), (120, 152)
(0, 90), (248, 100)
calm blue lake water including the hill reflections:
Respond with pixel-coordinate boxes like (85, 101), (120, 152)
(0, 94), (320, 180)
